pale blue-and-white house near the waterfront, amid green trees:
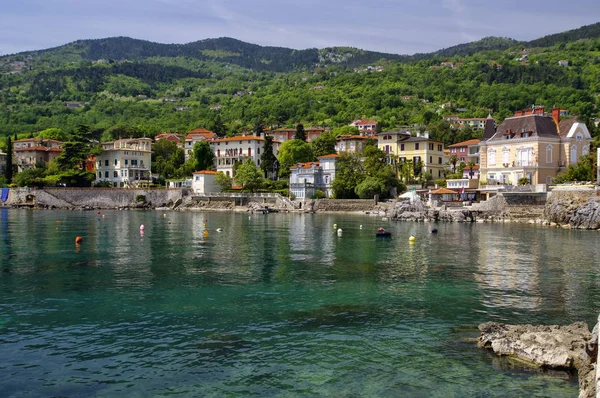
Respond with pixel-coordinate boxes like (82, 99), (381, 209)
(290, 154), (339, 199)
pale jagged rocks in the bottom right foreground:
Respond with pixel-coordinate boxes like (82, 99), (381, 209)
(477, 322), (598, 398)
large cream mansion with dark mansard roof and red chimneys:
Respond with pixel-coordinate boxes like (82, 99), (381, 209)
(479, 107), (591, 185)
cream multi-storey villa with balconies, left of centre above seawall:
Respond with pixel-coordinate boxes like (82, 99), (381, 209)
(96, 138), (152, 188)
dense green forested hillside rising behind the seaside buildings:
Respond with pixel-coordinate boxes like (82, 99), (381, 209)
(0, 20), (600, 148)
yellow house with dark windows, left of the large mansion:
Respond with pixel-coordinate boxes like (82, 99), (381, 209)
(377, 130), (444, 178)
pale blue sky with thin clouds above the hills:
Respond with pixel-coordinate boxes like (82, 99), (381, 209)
(0, 0), (600, 55)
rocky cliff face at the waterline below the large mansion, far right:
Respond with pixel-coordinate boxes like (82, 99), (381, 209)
(544, 191), (600, 229)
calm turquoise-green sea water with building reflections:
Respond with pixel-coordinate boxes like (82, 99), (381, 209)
(0, 209), (600, 397)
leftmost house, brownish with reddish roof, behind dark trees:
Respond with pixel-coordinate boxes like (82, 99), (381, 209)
(13, 138), (62, 173)
